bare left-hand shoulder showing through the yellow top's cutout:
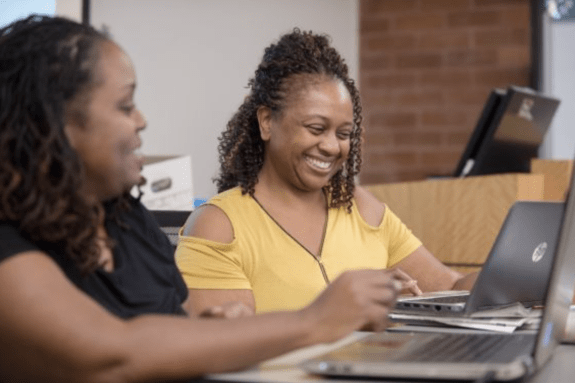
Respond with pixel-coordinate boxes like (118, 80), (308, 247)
(182, 204), (234, 243)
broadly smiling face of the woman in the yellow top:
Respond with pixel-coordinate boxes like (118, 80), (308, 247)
(258, 75), (353, 195)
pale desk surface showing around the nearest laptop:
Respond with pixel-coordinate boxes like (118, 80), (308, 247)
(206, 332), (575, 383)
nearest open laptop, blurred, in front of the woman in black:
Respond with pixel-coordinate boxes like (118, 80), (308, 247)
(301, 160), (575, 380)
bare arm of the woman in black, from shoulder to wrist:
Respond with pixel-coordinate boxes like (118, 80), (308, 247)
(0, 254), (321, 382)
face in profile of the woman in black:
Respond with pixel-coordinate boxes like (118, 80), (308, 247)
(65, 41), (146, 200)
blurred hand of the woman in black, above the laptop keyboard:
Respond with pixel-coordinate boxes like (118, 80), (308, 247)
(302, 269), (403, 342)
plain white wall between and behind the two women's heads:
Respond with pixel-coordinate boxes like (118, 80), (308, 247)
(90, 0), (358, 197)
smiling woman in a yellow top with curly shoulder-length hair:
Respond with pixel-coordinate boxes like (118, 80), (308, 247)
(176, 29), (475, 313)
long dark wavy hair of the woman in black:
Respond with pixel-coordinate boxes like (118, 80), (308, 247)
(0, 15), (113, 273)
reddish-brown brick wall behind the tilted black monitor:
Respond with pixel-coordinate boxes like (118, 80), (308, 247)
(359, 0), (531, 184)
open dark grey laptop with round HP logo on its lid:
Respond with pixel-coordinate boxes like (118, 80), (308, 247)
(395, 201), (565, 316)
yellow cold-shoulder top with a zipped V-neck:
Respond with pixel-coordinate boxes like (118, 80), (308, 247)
(176, 187), (421, 313)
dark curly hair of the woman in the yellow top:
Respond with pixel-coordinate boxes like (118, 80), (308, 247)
(215, 28), (362, 211)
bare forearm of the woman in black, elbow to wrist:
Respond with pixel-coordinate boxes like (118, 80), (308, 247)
(117, 312), (322, 381)
